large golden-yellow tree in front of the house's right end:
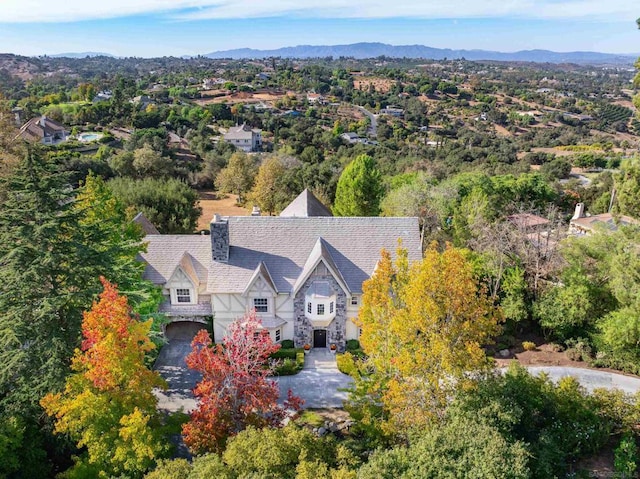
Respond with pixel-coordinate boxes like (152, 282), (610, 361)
(357, 245), (501, 432)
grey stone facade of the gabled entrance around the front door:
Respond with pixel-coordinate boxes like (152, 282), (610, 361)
(293, 263), (347, 352)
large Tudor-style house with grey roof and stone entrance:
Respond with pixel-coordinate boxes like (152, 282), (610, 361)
(138, 190), (421, 350)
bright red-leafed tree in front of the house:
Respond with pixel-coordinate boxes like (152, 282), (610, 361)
(182, 311), (302, 453)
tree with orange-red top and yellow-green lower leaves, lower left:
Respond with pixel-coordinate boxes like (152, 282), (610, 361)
(41, 278), (166, 478)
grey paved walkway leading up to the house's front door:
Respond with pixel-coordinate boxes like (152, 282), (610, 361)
(276, 348), (352, 408)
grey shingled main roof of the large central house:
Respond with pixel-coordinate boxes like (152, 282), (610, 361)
(141, 216), (422, 294)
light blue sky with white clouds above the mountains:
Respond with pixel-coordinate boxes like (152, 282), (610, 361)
(0, 0), (640, 57)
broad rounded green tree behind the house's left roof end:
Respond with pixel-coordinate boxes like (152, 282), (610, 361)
(108, 178), (202, 234)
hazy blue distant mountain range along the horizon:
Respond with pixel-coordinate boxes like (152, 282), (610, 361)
(204, 43), (637, 65)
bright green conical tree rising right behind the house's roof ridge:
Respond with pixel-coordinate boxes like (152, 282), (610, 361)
(333, 155), (384, 216)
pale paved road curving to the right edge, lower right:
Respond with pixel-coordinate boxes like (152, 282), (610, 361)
(527, 366), (640, 394)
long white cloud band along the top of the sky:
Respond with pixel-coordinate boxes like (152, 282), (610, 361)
(0, 0), (638, 23)
